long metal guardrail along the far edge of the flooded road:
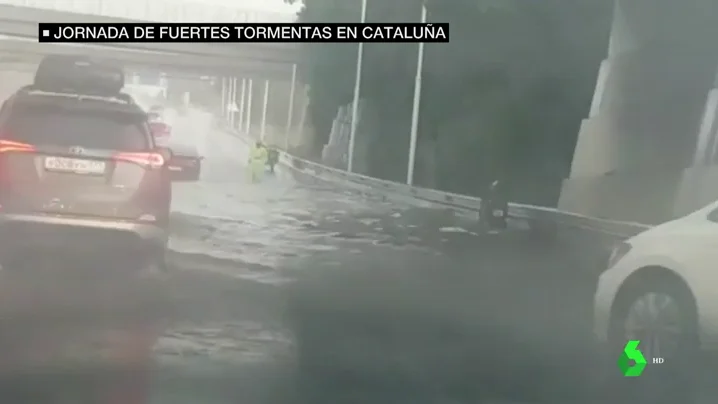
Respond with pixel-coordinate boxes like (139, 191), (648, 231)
(218, 119), (653, 238)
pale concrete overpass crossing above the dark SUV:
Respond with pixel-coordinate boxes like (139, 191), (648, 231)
(0, 0), (307, 150)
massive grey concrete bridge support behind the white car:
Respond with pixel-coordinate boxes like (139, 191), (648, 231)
(559, 0), (718, 223)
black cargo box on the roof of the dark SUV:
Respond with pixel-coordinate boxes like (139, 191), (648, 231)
(33, 55), (125, 95)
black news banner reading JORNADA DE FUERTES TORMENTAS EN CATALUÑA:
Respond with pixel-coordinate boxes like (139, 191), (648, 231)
(38, 23), (449, 43)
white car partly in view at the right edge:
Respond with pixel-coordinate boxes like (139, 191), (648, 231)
(594, 202), (718, 369)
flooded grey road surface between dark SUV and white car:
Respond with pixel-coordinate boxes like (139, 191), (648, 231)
(143, 111), (606, 403)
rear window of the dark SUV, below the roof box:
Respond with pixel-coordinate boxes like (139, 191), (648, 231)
(3, 106), (151, 151)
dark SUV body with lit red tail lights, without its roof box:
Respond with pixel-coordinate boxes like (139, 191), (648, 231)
(0, 86), (171, 271)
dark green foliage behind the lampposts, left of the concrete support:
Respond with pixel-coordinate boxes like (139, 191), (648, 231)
(289, 0), (612, 203)
